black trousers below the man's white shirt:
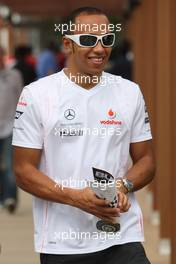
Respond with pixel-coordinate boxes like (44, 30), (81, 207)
(40, 242), (151, 264)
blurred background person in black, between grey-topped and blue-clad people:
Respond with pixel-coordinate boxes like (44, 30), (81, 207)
(14, 45), (37, 86)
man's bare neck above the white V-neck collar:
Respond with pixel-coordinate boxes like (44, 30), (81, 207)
(64, 67), (102, 90)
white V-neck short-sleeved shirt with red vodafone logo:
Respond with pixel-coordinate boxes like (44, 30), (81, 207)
(13, 71), (152, 254)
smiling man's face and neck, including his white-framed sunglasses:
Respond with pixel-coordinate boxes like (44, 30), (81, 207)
(64, 9), (115, 89)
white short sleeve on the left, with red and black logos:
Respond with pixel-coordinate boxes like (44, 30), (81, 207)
(12, 88), (43, 149)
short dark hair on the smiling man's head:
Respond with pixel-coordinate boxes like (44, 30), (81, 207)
(65, 6), (107, 35)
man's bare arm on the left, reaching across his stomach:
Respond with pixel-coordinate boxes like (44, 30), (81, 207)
(13, 146), (120, 221)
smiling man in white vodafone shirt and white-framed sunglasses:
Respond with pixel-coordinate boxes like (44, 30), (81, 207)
(13, 7), (154, 264)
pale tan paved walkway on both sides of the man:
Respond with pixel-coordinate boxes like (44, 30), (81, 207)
(0, 191), (170, 264)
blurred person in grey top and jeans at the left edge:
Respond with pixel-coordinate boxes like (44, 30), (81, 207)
(0, 47), (22, 213)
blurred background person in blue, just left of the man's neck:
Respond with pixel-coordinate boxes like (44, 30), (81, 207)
(37, 41), (60, 79)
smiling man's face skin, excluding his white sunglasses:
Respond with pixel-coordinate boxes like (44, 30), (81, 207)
(64, 14), (112, 75)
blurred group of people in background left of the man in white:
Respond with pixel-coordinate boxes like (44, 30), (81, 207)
(0, 42), (65, 213)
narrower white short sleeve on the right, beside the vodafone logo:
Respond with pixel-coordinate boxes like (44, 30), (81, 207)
(131, 89), (152, 143)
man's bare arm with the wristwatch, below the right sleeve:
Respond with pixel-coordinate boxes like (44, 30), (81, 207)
(120, 140), (155, 193)
